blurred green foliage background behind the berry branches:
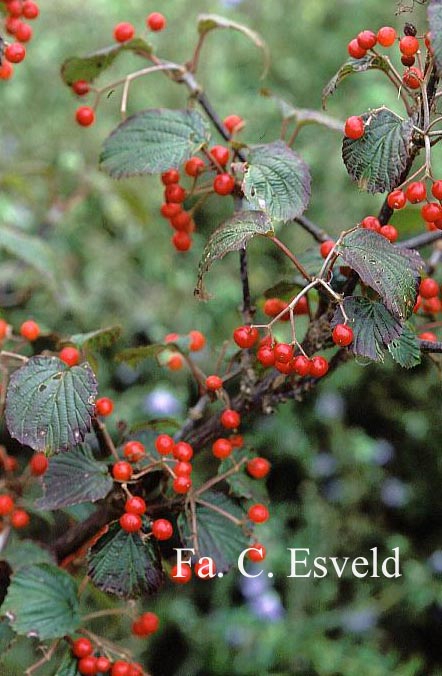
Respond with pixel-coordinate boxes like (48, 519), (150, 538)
(0, 0), (442, 676)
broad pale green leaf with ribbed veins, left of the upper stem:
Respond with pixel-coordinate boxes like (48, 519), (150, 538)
(100, 108), (209, 178)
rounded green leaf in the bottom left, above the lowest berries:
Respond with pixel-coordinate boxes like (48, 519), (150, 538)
(2, 563), (81, 641)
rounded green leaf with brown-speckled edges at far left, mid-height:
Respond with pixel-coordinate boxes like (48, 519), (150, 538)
(6, 356), (97, 455)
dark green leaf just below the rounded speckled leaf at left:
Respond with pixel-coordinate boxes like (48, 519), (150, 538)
(37, 444), (113, 509)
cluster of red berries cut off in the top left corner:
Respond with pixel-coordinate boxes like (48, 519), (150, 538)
(0, 0), (40, 80)
